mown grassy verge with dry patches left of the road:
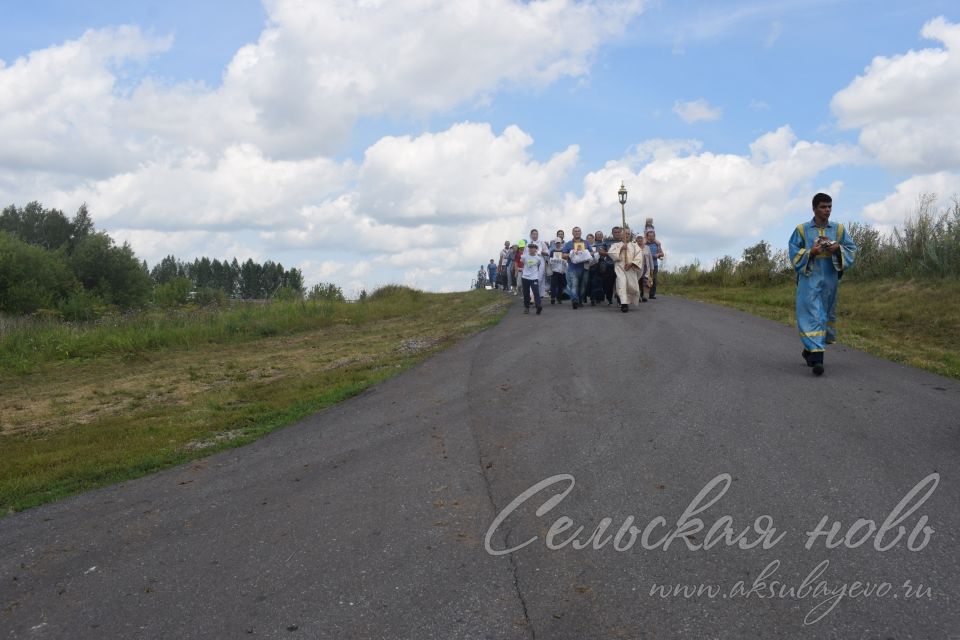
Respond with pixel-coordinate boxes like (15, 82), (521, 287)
(0, 289), (509, 514)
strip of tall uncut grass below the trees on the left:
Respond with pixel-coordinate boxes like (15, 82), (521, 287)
(0, 285), (424, 373)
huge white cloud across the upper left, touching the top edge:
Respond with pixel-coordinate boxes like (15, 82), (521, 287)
(0, 0), (643, 188)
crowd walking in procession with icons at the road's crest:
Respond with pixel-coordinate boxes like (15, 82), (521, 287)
(487, 218), (664, 314)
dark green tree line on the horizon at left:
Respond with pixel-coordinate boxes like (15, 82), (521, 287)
(0, 202), (343, 320)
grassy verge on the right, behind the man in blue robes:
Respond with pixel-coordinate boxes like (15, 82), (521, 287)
(662, 279), (960, 379)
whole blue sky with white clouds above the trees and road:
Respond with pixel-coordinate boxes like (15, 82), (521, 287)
(0, 0), (960, 297)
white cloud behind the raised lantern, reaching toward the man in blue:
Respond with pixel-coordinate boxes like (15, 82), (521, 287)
(565, 126), (858, 255)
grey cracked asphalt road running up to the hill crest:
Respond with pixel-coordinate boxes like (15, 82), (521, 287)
(0, 292), (960, 639)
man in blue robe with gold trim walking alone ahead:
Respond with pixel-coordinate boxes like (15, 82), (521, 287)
(790, 193), (857, 376)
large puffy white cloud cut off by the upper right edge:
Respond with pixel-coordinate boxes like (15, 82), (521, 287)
(831, 17), (960, 172)
